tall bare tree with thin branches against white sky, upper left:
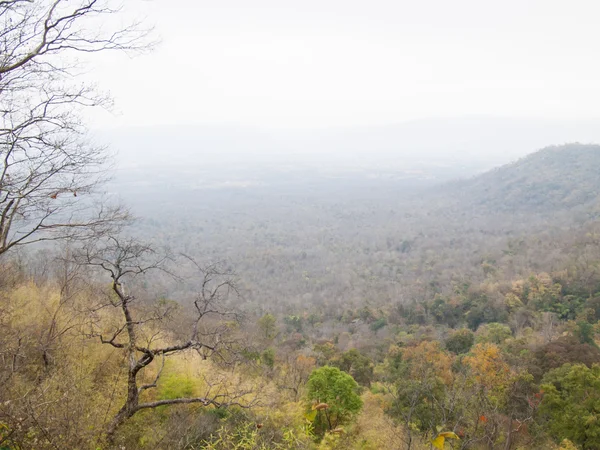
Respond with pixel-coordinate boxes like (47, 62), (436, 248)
(0, 0), (152, 255)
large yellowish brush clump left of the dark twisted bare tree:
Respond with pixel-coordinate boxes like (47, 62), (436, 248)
(0, 282), (130, 442)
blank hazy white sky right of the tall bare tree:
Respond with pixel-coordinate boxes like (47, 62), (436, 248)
(92, 0), (600, 128)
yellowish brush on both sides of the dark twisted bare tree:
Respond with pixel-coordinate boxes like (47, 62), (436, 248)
(0, 282), (262, 449)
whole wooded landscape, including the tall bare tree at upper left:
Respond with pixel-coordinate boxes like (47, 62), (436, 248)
(0, 0), (600, 450)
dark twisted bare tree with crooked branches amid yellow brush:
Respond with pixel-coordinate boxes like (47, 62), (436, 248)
(78, 237), (256, 439)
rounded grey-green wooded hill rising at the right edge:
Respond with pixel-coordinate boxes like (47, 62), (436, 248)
(446, 143), (600, 213)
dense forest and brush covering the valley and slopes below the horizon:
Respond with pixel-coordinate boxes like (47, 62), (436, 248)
(0, 145), (600, 449)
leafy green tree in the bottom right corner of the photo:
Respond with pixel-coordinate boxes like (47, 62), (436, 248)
(540, 364), (600, 450)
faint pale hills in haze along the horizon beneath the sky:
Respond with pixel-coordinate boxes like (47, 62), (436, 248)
(104, 116), (600, 177)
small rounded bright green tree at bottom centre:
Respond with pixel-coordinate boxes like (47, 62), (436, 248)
(307, 366), (362, 436)
